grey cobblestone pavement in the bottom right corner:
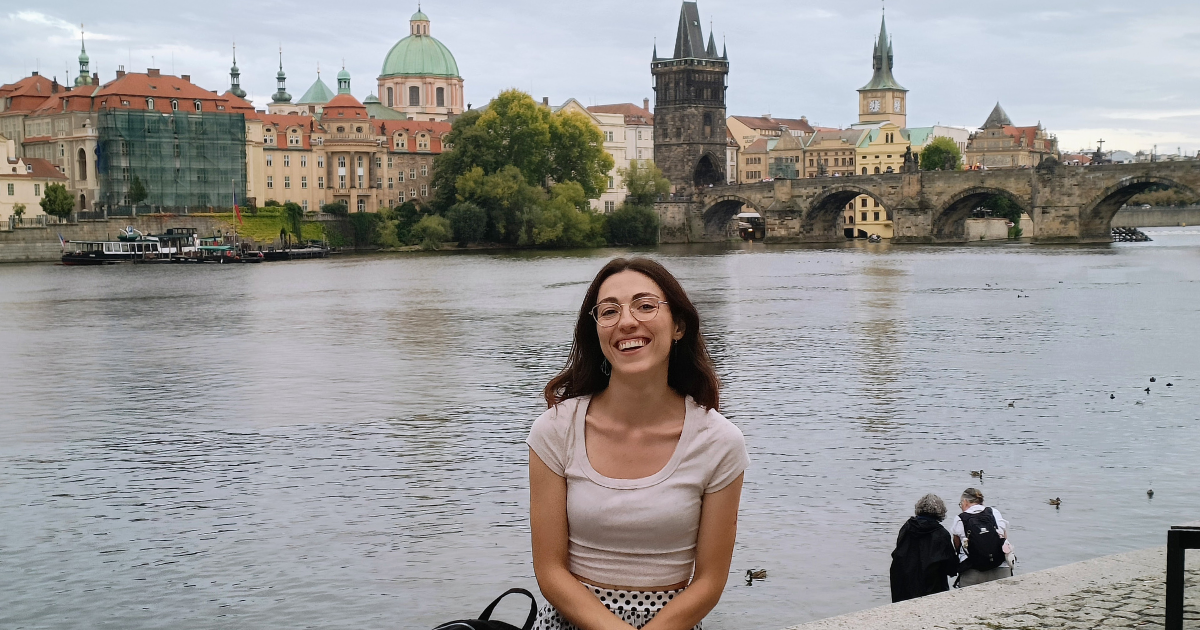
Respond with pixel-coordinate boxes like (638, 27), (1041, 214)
(958, 570), (1200, 630)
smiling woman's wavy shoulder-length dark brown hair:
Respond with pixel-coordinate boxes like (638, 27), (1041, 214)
(542, 258), (721, 409)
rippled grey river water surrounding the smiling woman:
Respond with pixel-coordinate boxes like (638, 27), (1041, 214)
(7, 228), (1200, 630)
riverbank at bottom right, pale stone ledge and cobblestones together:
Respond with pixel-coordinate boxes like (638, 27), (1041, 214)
(787, 547), (1200, 630)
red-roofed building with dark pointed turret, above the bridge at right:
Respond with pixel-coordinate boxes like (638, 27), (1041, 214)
(964, 103), (1058, 168)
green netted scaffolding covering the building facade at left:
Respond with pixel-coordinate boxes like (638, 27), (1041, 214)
(96, 109), (246, 211)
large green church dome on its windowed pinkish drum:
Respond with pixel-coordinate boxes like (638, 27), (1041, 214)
(378, 7), (464, 121)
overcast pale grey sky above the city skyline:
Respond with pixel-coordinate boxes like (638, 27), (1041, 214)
(7, 0), (1200, 152)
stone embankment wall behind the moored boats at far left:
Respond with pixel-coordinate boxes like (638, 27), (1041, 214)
(0, 215), (234, 263)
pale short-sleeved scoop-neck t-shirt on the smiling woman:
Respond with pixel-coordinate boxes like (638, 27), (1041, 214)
(526, 396), (750, 587)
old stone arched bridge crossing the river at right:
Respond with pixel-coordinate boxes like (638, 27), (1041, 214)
(655, 158), (1200, 242)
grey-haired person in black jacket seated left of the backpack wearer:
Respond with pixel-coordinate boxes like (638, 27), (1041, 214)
(890, 494), (959, 601)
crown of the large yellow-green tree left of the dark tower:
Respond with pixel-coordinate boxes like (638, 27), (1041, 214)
(433, 90), (613, 214)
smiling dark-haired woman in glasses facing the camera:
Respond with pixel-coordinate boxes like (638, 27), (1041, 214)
(528, 258), (749, 630)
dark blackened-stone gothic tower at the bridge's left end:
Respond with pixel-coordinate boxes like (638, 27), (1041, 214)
(650, 2), (730, 193)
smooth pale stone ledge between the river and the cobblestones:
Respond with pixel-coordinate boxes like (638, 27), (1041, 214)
(787, 546), (1166, 630)
